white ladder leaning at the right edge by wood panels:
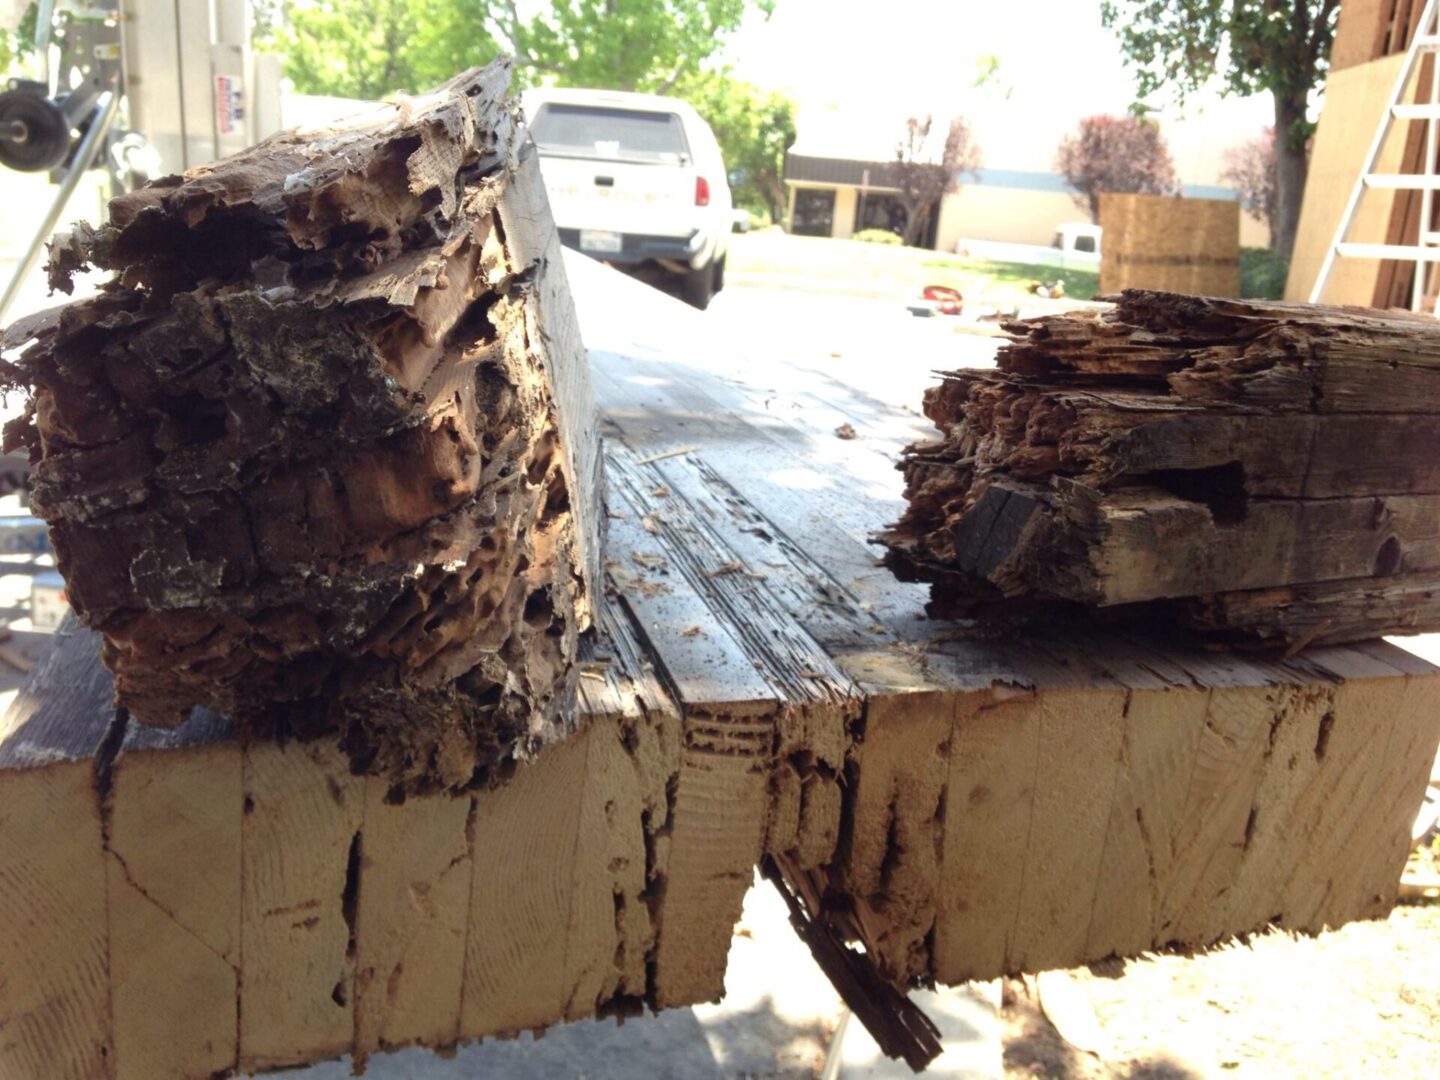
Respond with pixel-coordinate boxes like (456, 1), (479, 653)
(1310, 0), (1440, 314)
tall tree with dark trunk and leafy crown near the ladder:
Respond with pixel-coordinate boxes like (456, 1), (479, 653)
(1100, 0), (1339, 255)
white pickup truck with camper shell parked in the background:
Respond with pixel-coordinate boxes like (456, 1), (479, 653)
(521, 88), (733, 308)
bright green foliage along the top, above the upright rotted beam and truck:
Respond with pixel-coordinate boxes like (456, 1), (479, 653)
(259, 0), (775, 98)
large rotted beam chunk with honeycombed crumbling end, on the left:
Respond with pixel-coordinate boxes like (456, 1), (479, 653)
(6, 62), (599, 791)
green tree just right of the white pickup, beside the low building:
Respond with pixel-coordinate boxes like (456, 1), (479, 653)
(674, 72), (795, 222)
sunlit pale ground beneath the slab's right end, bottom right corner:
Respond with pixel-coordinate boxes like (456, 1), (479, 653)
(1002, 903), (1440, 1080)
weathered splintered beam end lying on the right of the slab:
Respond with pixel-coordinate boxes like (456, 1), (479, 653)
(883, 291), (1440, 648)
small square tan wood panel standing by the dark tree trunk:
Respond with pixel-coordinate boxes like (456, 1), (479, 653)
(1100, 194), (1240, 297)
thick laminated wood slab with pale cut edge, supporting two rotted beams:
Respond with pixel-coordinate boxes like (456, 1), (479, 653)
(0, 259), (1440, 1079)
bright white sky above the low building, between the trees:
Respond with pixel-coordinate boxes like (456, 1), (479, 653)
(726, 0), (1272, 183)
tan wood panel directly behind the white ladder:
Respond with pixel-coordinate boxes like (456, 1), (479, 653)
(1284, 55), (1405, 307)
